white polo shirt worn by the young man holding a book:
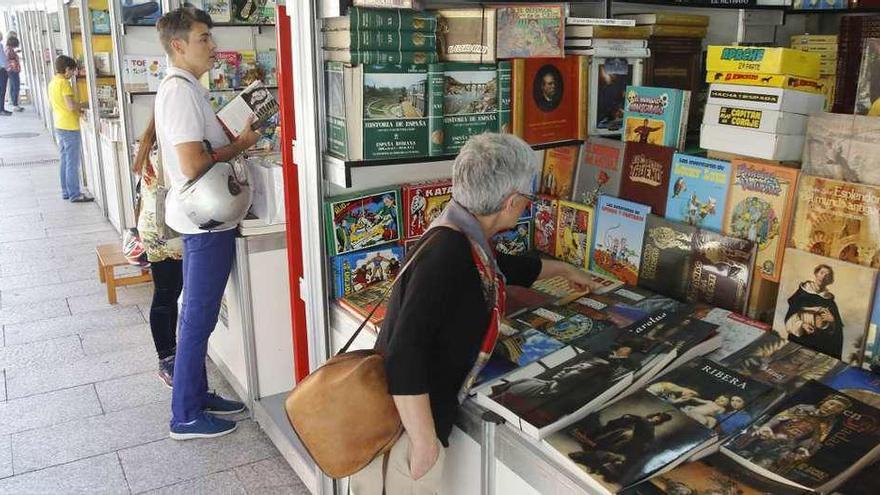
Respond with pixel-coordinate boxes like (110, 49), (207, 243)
(154, 66), (235, 234)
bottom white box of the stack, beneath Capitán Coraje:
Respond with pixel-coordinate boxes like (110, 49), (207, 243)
(700, 124), (804, 161)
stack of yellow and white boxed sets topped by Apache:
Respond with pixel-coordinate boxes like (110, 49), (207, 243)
(700, 46), (825, 161)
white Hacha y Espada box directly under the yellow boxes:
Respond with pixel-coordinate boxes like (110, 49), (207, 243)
(706, 84), (825, 115)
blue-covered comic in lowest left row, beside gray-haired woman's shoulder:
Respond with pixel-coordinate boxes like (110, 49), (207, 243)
(330, 245), (403, 298)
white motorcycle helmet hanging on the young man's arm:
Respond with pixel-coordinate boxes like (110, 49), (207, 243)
(179, 162), (253, 231)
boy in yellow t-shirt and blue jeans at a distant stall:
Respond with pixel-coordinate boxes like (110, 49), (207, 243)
(47, 55), (94, 203)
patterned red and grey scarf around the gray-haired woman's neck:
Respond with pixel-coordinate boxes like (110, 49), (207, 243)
(429, 199), (505, 404)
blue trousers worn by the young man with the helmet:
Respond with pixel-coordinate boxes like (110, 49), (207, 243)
(171, 229), (235, 425)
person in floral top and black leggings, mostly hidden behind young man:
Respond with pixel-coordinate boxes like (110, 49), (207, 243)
(134, 119), (183, 388)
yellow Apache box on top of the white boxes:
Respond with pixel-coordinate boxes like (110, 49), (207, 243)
(706, 45), (819, 79)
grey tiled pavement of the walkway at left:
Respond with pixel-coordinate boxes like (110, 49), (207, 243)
(0, 108), (308, 495)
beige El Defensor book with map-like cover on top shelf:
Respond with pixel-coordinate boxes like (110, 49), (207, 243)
(495, 4), (565, 58)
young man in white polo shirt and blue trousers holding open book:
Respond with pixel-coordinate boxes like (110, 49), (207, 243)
(155, 8), (259, 440)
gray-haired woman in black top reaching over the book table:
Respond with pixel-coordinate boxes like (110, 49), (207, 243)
(351, 134), (589, 495)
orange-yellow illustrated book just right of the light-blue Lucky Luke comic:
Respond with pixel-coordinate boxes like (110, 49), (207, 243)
(721, 158), (799, 282)
